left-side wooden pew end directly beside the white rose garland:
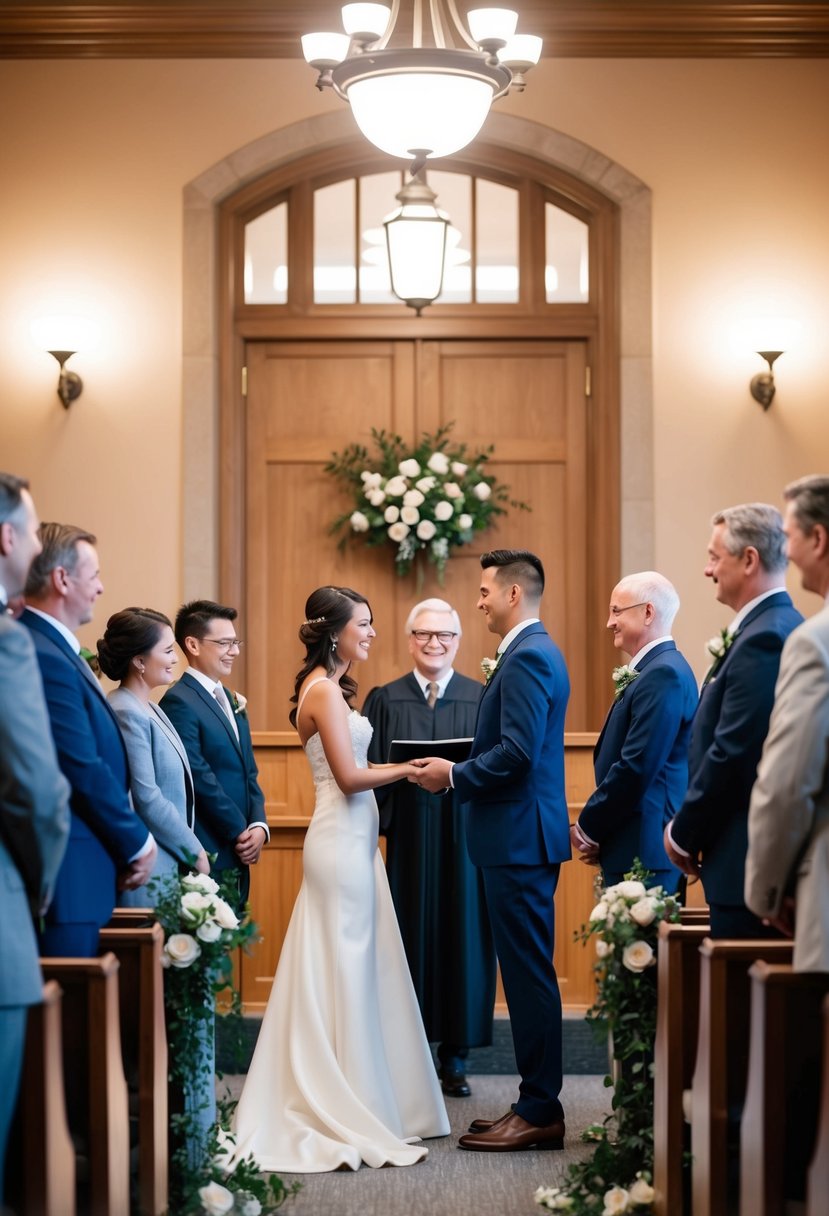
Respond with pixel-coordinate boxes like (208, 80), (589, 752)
(101, 917), (169, 1216)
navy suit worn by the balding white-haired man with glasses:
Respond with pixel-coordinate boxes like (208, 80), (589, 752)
(579, 641), (698, 891)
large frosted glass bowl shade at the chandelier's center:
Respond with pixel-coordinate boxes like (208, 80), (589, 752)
(332, 47), (511, 158)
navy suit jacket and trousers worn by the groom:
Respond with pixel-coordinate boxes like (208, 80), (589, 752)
(452, 623), (570, 1127)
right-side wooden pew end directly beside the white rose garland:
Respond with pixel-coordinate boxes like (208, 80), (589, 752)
(654, 910), (709, 1216)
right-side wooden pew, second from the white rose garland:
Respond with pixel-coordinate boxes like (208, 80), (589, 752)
(690, 938), (793, 1216)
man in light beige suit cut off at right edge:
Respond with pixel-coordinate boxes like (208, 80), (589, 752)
(745, 477), (829, 972)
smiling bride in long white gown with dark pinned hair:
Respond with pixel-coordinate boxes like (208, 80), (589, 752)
(233, 587), (449, 1173)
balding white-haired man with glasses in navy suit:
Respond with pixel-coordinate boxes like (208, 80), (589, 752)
(570, 570), (698, 894)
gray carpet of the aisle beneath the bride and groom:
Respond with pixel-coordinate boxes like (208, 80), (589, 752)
(220, 1075), (610, 1216)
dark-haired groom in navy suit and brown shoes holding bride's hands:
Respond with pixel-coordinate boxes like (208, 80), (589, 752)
(411, 550), (570, 1153)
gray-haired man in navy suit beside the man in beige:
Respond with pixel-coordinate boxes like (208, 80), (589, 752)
(665, 502), (803, 938)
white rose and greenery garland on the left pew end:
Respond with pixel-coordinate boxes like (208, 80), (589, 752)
(151, 873), (299, 1216)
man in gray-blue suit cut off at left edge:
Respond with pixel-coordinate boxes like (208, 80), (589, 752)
(0, 473), (69, 1209)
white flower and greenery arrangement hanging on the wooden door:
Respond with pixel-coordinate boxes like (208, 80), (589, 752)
(325, 422), (530, 582)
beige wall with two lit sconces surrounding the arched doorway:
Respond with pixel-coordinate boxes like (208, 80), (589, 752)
(0, 60), (829, 670)
